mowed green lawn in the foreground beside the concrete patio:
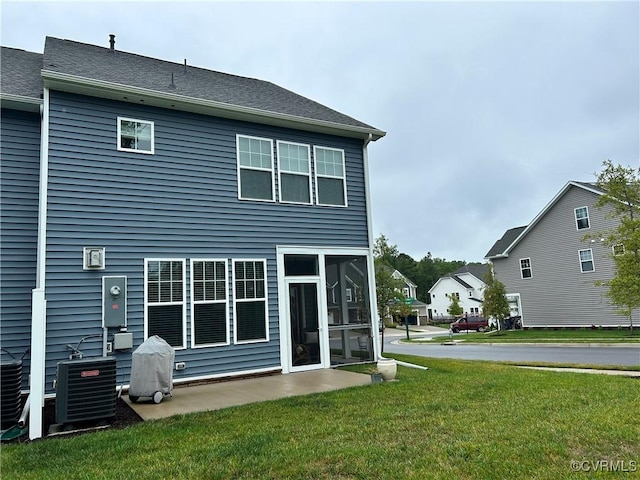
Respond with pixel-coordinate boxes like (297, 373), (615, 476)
(0, 355), (640, 480)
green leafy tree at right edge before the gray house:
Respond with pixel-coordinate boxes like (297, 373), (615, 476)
(585, 160), (640, 331)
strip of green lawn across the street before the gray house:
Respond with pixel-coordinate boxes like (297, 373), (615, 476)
(424, 328), (640, 343)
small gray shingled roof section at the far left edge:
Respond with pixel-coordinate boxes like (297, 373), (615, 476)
(0, 47), (42, 100)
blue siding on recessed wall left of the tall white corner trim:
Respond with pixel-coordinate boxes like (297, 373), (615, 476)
(0, 109), (40, 388)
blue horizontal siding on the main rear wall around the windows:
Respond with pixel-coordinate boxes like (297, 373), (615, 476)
(41, 92), (368, 392)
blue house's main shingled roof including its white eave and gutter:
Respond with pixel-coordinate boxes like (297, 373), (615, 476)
(33, 37), (385, 140)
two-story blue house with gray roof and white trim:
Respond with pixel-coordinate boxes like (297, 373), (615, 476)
(0, 37), (385, 438)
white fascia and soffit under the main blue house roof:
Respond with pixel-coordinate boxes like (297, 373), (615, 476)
(42, 70), (386, 140)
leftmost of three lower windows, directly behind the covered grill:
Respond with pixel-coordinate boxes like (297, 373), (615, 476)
(145, 260), (187, 348)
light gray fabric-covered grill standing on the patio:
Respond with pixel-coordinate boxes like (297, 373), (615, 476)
(129, 335), (175, 397)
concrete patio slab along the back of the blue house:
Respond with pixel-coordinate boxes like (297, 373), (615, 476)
(122, 368), (371, 420)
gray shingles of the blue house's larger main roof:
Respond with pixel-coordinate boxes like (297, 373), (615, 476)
(43, 37), (384, 135)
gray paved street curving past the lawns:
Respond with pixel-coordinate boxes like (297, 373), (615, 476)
(384, 327), (640, 365)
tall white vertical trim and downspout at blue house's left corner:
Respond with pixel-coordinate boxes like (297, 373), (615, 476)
(29, 88), (49, 440)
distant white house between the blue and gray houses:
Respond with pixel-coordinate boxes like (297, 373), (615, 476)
(429, 263), (488, 321)
